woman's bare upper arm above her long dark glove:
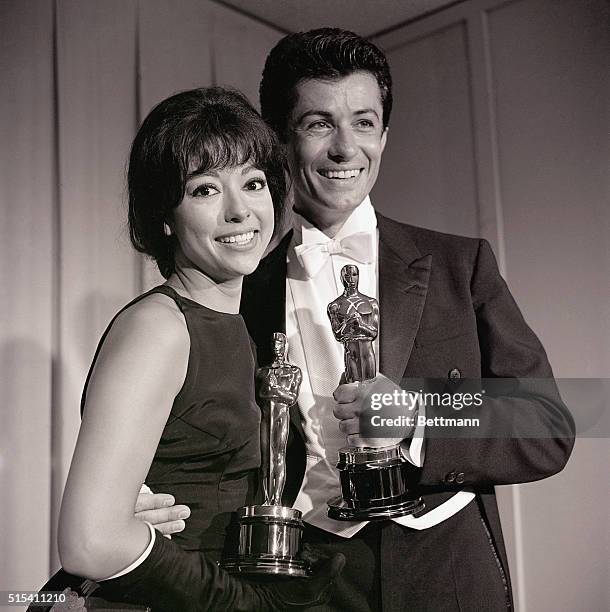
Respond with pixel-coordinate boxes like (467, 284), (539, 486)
(59, 295), (190, 579)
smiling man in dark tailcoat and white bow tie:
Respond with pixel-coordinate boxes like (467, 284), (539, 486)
(235, 29), (573, 612)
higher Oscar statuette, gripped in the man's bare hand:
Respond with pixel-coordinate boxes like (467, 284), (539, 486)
(328, 265), (423, 521)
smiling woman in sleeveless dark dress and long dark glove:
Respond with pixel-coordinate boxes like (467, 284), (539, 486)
(39, 88), (342, 610)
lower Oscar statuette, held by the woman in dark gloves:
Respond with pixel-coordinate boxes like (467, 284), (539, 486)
(221, 333), (310, 578)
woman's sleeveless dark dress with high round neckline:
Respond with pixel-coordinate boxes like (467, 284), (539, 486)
(35, 285), (260, 611)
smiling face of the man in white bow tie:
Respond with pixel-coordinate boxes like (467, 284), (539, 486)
(287, 72), (387, 229)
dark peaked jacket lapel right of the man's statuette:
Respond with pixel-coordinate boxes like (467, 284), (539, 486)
(377, 214), (432, 383)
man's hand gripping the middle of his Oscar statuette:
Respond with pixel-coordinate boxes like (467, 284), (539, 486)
(333, 374), (417, 448)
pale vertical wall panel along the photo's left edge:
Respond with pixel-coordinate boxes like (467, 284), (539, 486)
(0, 3), (56, 590)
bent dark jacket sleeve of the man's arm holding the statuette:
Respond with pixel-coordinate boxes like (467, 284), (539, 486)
(415, 240), (574, 487)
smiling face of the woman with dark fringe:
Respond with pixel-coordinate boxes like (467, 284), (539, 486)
(171, 163), (273, 282)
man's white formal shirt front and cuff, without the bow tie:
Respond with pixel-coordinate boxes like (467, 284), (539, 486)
(286, 197), (474, 537)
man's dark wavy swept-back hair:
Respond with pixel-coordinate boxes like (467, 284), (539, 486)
(260, 28), (392, 142)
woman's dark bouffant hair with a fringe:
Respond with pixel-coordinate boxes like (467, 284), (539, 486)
(127, 87), (286, 278)
